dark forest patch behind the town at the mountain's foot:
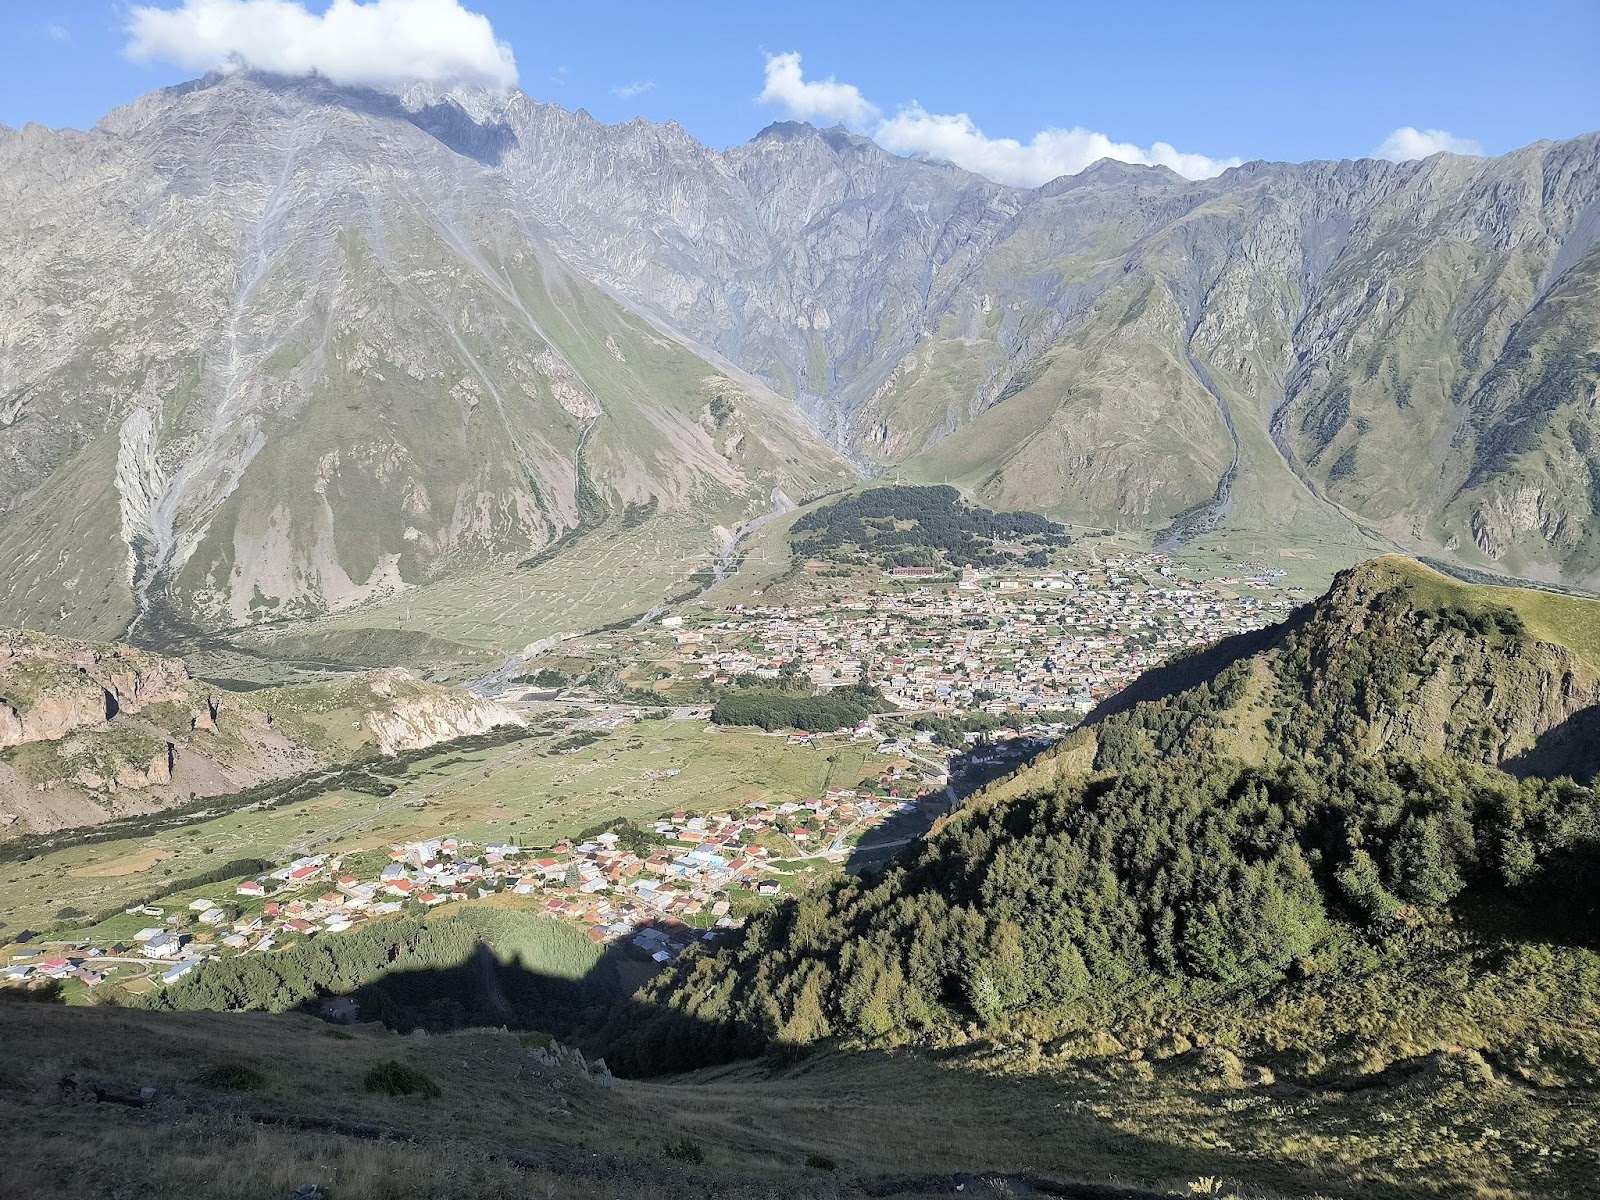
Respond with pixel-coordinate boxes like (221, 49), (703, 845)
(789, 485), (1070, 568)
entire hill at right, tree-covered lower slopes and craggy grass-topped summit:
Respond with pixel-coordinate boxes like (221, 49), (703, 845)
(606, 560), (1600, 1107)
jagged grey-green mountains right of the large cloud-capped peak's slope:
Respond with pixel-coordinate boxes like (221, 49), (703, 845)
(467, 98), (1600, 581)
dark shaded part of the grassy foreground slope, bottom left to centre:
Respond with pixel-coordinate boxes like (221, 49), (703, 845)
(0, 1003), (1440, 1200)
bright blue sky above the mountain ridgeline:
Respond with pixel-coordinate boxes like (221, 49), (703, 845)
(0, 0), (1600, 182)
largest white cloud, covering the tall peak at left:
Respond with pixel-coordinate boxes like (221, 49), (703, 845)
(123, 0), (517, 88)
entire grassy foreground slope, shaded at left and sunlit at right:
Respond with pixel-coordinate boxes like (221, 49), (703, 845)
(0, 1005), (1600, 1200)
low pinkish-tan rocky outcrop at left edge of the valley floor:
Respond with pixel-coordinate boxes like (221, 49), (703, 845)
(0, 630), (522, 830)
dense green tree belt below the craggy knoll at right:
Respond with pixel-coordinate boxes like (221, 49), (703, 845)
(605, 757), (1600, 1074)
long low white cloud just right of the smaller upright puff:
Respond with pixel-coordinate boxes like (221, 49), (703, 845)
(872, 104), (1238, 187)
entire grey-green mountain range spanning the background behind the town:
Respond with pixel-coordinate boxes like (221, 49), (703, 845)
(0, 74), (1600, 642)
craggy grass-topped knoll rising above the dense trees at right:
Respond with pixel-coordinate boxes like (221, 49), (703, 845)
(1088, 557), (1600, 781)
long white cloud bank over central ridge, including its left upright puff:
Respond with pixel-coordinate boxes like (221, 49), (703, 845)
(757, 53), (1238, 187)
